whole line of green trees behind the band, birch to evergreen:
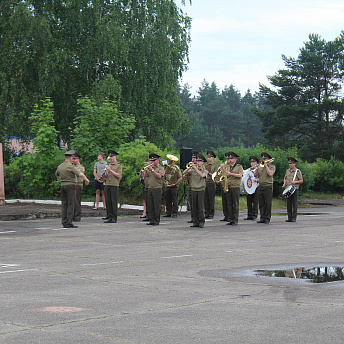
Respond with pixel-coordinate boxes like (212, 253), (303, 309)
(0, 0), (344, 169)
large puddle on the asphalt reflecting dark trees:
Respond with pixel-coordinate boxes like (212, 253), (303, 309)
(254, 266), (344, 283)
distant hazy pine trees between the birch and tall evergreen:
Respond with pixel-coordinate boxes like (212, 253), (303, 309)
(177, 81), (262, 150)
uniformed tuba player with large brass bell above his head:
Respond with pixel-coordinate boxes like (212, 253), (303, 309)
(163, 154), (183, 218)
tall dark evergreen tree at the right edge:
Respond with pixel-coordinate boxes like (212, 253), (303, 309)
(254, 33), (344, 160)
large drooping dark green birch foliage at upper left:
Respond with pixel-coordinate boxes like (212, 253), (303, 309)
(0, 0), (191, 146)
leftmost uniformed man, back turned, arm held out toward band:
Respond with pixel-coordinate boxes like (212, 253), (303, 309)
(55, 150), (90, 228)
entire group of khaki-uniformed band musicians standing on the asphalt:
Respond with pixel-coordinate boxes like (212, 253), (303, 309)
(56, 149), (303, 228)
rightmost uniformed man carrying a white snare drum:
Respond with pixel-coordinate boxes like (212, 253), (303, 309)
(283, 156), (303, 222)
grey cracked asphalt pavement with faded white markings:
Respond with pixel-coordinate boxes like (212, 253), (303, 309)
(0, 200), (344, 344)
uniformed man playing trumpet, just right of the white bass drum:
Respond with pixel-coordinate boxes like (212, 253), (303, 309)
(254, 152), (276, 224)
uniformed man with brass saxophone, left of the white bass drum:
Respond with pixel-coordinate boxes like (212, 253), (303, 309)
(220, 152), (244, 226)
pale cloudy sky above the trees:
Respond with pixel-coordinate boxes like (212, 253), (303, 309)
(181, 0), (344, 95)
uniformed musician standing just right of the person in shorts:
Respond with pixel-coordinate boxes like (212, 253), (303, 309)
(103, 149), (122, 223)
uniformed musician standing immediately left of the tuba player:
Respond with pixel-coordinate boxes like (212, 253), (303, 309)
(145, 153), (165, 226)
